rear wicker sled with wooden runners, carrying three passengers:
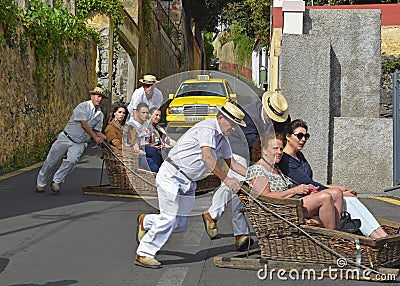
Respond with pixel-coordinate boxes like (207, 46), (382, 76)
(82, 143), (221, 197)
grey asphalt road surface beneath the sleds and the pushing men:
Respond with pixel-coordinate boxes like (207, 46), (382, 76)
(0, 147), (400, 286)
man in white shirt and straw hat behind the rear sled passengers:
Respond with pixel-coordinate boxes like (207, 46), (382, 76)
(128, 74), (164, 121)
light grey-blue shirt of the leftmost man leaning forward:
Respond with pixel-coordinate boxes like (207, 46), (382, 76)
(64, 100), (104, 143)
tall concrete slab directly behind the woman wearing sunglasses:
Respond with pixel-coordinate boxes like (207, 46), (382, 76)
(280, 34), (330, 182)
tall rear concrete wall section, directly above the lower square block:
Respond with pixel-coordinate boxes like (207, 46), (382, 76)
(304, 9), (381, 117)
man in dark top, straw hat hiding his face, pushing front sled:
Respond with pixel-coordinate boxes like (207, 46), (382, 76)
(203, 91), (290, 251)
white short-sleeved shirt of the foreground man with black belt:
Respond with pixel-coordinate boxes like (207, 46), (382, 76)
(168, 118), (232, 181)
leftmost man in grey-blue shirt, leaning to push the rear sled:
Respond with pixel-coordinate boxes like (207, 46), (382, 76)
(36, 87), (107, 194)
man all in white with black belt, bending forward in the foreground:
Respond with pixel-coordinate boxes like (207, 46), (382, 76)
(135, 102), (246, 268)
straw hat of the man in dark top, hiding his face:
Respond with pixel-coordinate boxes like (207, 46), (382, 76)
(262, 91), (289, 122)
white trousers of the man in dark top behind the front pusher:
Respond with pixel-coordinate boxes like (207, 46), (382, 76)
(208, 154), (249, 236)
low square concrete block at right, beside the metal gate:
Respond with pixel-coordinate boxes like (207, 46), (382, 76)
(332, 117), (393, 194)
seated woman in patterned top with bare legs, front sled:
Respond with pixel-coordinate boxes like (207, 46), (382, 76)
(246, 132), (343, 229)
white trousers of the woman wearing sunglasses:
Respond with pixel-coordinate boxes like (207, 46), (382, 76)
(343, 197), (380, 236)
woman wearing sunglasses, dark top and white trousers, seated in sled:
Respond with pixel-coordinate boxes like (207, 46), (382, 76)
(278, 119), (387, 238)
